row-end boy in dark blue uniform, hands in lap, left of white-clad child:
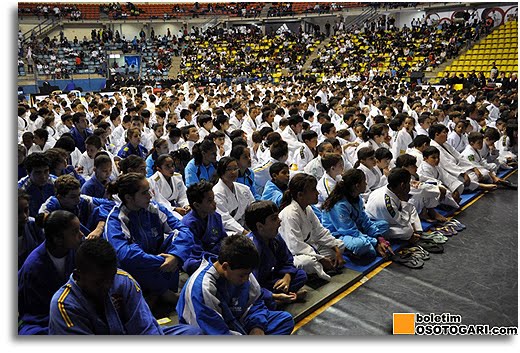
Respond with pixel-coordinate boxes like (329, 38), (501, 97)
(245, 201), (307, 309)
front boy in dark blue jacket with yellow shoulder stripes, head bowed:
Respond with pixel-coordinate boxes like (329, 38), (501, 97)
(49, 239), (201, 335)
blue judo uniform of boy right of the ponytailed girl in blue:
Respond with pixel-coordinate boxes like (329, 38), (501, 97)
(181, 209), (227, 275)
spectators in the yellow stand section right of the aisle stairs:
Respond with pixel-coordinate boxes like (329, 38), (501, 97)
(311, 12), (486, 84)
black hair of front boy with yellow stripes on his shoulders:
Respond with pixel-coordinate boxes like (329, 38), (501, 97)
(76, 238), (117, 273)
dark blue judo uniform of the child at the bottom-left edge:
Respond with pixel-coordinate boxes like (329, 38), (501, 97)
(18, 242), (75, 335)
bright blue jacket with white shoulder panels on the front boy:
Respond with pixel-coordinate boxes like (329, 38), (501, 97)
(177, 256), (294, 335)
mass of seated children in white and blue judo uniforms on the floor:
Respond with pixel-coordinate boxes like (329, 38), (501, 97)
(17, 71), (518, 334)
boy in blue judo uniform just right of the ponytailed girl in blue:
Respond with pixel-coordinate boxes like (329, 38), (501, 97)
(181, 180), (227, 275)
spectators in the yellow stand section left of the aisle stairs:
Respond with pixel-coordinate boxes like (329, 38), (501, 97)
(181, 26), (317, 83)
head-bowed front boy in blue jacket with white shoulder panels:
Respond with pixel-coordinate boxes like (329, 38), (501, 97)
(177, 234), (294, 335)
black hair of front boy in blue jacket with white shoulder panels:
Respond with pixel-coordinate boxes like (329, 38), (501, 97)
(218, 234), (260, 270)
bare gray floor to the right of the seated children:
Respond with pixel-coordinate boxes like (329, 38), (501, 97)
(294, 173), (518, 336)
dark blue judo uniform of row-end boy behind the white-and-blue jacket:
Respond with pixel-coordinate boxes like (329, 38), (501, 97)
(247, 232), (307, 310)
